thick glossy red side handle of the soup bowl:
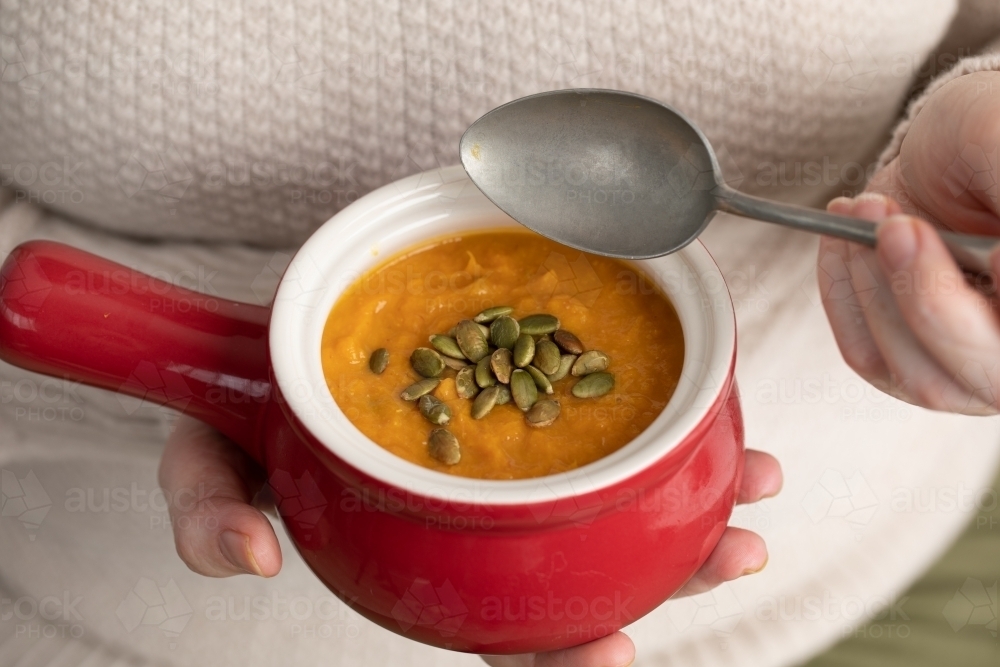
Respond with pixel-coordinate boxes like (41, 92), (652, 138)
(0, 241), (271, 461)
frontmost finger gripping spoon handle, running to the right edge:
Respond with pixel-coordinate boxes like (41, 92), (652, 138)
(877, 215), (1000, 413)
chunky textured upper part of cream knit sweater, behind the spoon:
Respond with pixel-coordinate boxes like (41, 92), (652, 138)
(0, 0), (984, 246)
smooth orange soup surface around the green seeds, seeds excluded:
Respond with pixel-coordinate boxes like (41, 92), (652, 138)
(322, 229), (684, 479)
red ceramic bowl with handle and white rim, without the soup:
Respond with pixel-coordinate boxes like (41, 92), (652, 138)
(0, 167), (743, 653)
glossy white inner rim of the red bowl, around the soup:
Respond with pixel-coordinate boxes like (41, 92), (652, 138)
(269, 165), (736, 505)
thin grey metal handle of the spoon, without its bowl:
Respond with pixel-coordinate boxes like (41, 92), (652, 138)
(716, 186), (1000, 274)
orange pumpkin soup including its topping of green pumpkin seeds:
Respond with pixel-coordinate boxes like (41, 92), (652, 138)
(321, 229), (684, 479)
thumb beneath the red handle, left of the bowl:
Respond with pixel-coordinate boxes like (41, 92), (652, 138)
(159, 417), (281, 577)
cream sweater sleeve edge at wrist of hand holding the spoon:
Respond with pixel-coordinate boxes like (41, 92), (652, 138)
(877, 0), (1000, 169)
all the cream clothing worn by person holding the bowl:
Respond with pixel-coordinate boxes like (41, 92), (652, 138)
(0, 0), (1000, 667)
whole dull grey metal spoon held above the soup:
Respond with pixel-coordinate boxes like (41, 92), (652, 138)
(459, 89), (998, 273)
